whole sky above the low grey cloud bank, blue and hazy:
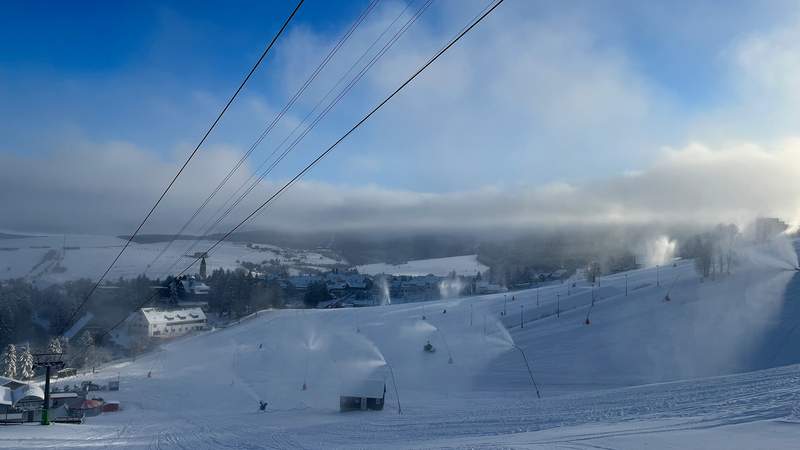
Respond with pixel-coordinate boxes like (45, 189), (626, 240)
(0, 0), (800, 232)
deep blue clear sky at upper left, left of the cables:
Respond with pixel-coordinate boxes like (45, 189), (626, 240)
(0, 2), (359, 152)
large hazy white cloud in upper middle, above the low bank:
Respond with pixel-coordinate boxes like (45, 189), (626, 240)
(260, 2), (678, 190)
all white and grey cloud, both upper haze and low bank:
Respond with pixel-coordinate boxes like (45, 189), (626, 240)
(0, 2), (800, 239)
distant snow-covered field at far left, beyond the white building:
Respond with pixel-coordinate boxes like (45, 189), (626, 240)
(0, 235), (339, 283)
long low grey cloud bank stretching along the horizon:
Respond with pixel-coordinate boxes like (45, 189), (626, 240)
(0, 139), (800, 234)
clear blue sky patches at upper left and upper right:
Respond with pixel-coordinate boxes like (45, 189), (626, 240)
(0, 0), (774, 171)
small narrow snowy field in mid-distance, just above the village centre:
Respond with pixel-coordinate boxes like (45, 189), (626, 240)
(356, 255), (488, 277)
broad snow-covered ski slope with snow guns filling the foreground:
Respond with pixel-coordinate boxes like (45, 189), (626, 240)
(0, 241), (800, 449)
